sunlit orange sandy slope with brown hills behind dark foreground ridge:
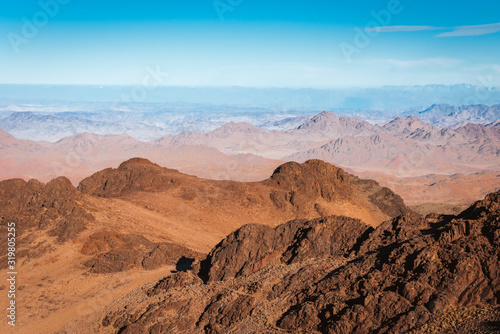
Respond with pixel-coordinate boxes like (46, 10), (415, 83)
(0, 158), (410, 333)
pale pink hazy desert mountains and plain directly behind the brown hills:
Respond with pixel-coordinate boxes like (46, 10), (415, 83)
(0, 111), (500, 213)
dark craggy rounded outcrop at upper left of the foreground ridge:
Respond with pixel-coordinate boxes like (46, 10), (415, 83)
(198, 216), (371, 282)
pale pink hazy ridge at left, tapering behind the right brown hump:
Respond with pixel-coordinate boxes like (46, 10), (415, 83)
(0, 129), (281, 184)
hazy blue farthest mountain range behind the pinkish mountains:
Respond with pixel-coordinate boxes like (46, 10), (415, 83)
(0, 103), (500, 142)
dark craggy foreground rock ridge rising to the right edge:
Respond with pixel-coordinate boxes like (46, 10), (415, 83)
(102, 192), (500, 333)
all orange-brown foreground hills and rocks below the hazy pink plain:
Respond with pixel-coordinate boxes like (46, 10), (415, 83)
(0, 158), (500, 333)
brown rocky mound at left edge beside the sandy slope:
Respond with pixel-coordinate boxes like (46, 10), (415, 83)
(0, 177), (94, 265)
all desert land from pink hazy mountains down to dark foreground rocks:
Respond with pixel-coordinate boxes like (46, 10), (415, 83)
(0, 112), (500, 333)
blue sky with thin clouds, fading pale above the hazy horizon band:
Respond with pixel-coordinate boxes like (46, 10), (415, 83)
(0, 0), (500, 88)
